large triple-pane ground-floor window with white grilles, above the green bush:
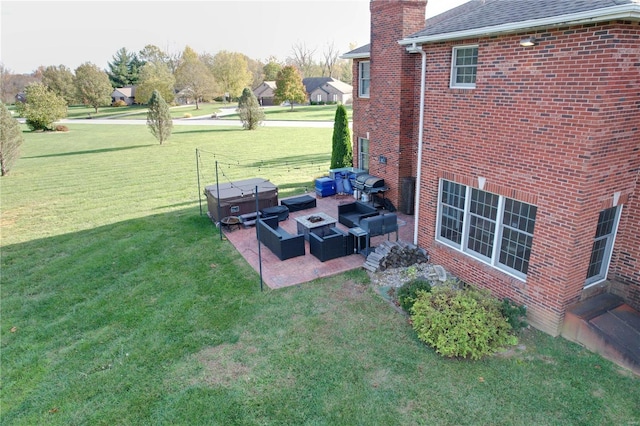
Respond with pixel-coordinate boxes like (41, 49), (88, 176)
(436, 180), (537, 279)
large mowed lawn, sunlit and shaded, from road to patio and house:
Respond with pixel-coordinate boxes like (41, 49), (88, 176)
(0, 124), (640, 425)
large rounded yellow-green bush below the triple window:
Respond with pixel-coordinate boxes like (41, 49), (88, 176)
(411, 285), (518, 359)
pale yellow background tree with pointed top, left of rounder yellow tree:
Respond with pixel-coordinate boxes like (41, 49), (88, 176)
(176, 46), (216, 109)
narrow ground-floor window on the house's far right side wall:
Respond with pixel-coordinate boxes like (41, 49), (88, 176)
(585, 207), (620, 286)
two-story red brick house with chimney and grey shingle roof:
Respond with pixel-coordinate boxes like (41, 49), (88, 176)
(342, 0), (640, 336)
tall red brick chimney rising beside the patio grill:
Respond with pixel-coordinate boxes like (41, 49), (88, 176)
(368, 0), (427, 207)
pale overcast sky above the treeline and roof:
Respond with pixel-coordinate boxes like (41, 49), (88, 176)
(0, 0), (468, 74)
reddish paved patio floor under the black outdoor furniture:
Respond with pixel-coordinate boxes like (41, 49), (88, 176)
(223, 193), (414, 289)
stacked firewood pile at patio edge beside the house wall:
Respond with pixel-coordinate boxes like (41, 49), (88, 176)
(362, 241), (429, 272)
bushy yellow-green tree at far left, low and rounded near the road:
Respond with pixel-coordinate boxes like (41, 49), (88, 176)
(16, 83), (67, 130)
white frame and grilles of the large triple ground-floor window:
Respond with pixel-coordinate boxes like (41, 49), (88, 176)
(435, 179), (537, 281)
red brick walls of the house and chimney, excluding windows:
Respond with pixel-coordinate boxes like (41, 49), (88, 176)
(354, 8), (640, 335)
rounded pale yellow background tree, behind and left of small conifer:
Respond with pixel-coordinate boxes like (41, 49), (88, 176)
(211, 50), (253, 99)
